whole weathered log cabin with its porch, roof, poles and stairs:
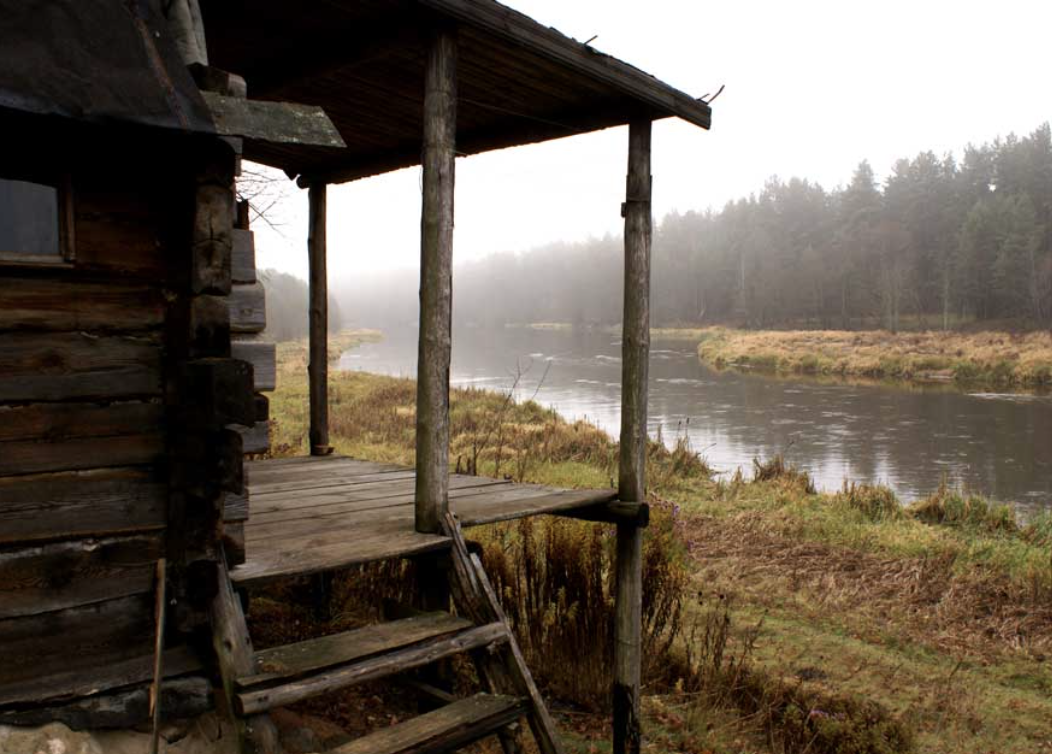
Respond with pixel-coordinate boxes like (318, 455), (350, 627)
(0, 0), (710, 754)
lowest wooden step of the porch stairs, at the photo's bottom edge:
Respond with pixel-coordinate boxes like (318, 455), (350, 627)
(331, 694), (528, 754)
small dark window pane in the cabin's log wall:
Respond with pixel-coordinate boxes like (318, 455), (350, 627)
(0, 179), (62, 259)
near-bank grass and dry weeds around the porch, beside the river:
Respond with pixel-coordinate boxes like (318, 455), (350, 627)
(256, 332), (1052, 754)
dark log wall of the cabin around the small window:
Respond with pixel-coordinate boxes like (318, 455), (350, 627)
(0, 124), (241, 710)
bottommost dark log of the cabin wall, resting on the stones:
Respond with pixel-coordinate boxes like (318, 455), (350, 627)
(0, 675), (213, 731)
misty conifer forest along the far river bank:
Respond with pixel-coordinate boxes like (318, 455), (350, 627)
(343, 123), (1052, 330)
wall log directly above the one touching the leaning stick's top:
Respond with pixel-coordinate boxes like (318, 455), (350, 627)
(0, 469), (167, 544)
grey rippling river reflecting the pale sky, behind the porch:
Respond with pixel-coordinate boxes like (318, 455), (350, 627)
(340, 328), (1052, 510)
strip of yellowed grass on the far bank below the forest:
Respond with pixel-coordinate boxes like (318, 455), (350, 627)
(677, 327), (1052, 388)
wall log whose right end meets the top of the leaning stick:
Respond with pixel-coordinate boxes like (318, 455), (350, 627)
(0, 534), (164, 619)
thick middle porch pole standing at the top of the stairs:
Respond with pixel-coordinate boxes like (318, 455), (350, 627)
(416, 29), (457, 532)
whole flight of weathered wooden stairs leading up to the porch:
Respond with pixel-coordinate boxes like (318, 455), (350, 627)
(211, 514), (563, 754)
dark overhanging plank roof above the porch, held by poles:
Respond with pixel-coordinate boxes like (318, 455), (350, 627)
(202, 0), (710, 183)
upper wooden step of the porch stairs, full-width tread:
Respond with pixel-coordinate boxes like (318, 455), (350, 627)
(235, 613), (508, 715)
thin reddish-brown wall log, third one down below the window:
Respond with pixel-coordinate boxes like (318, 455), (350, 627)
(0, 401), (164, 443)
